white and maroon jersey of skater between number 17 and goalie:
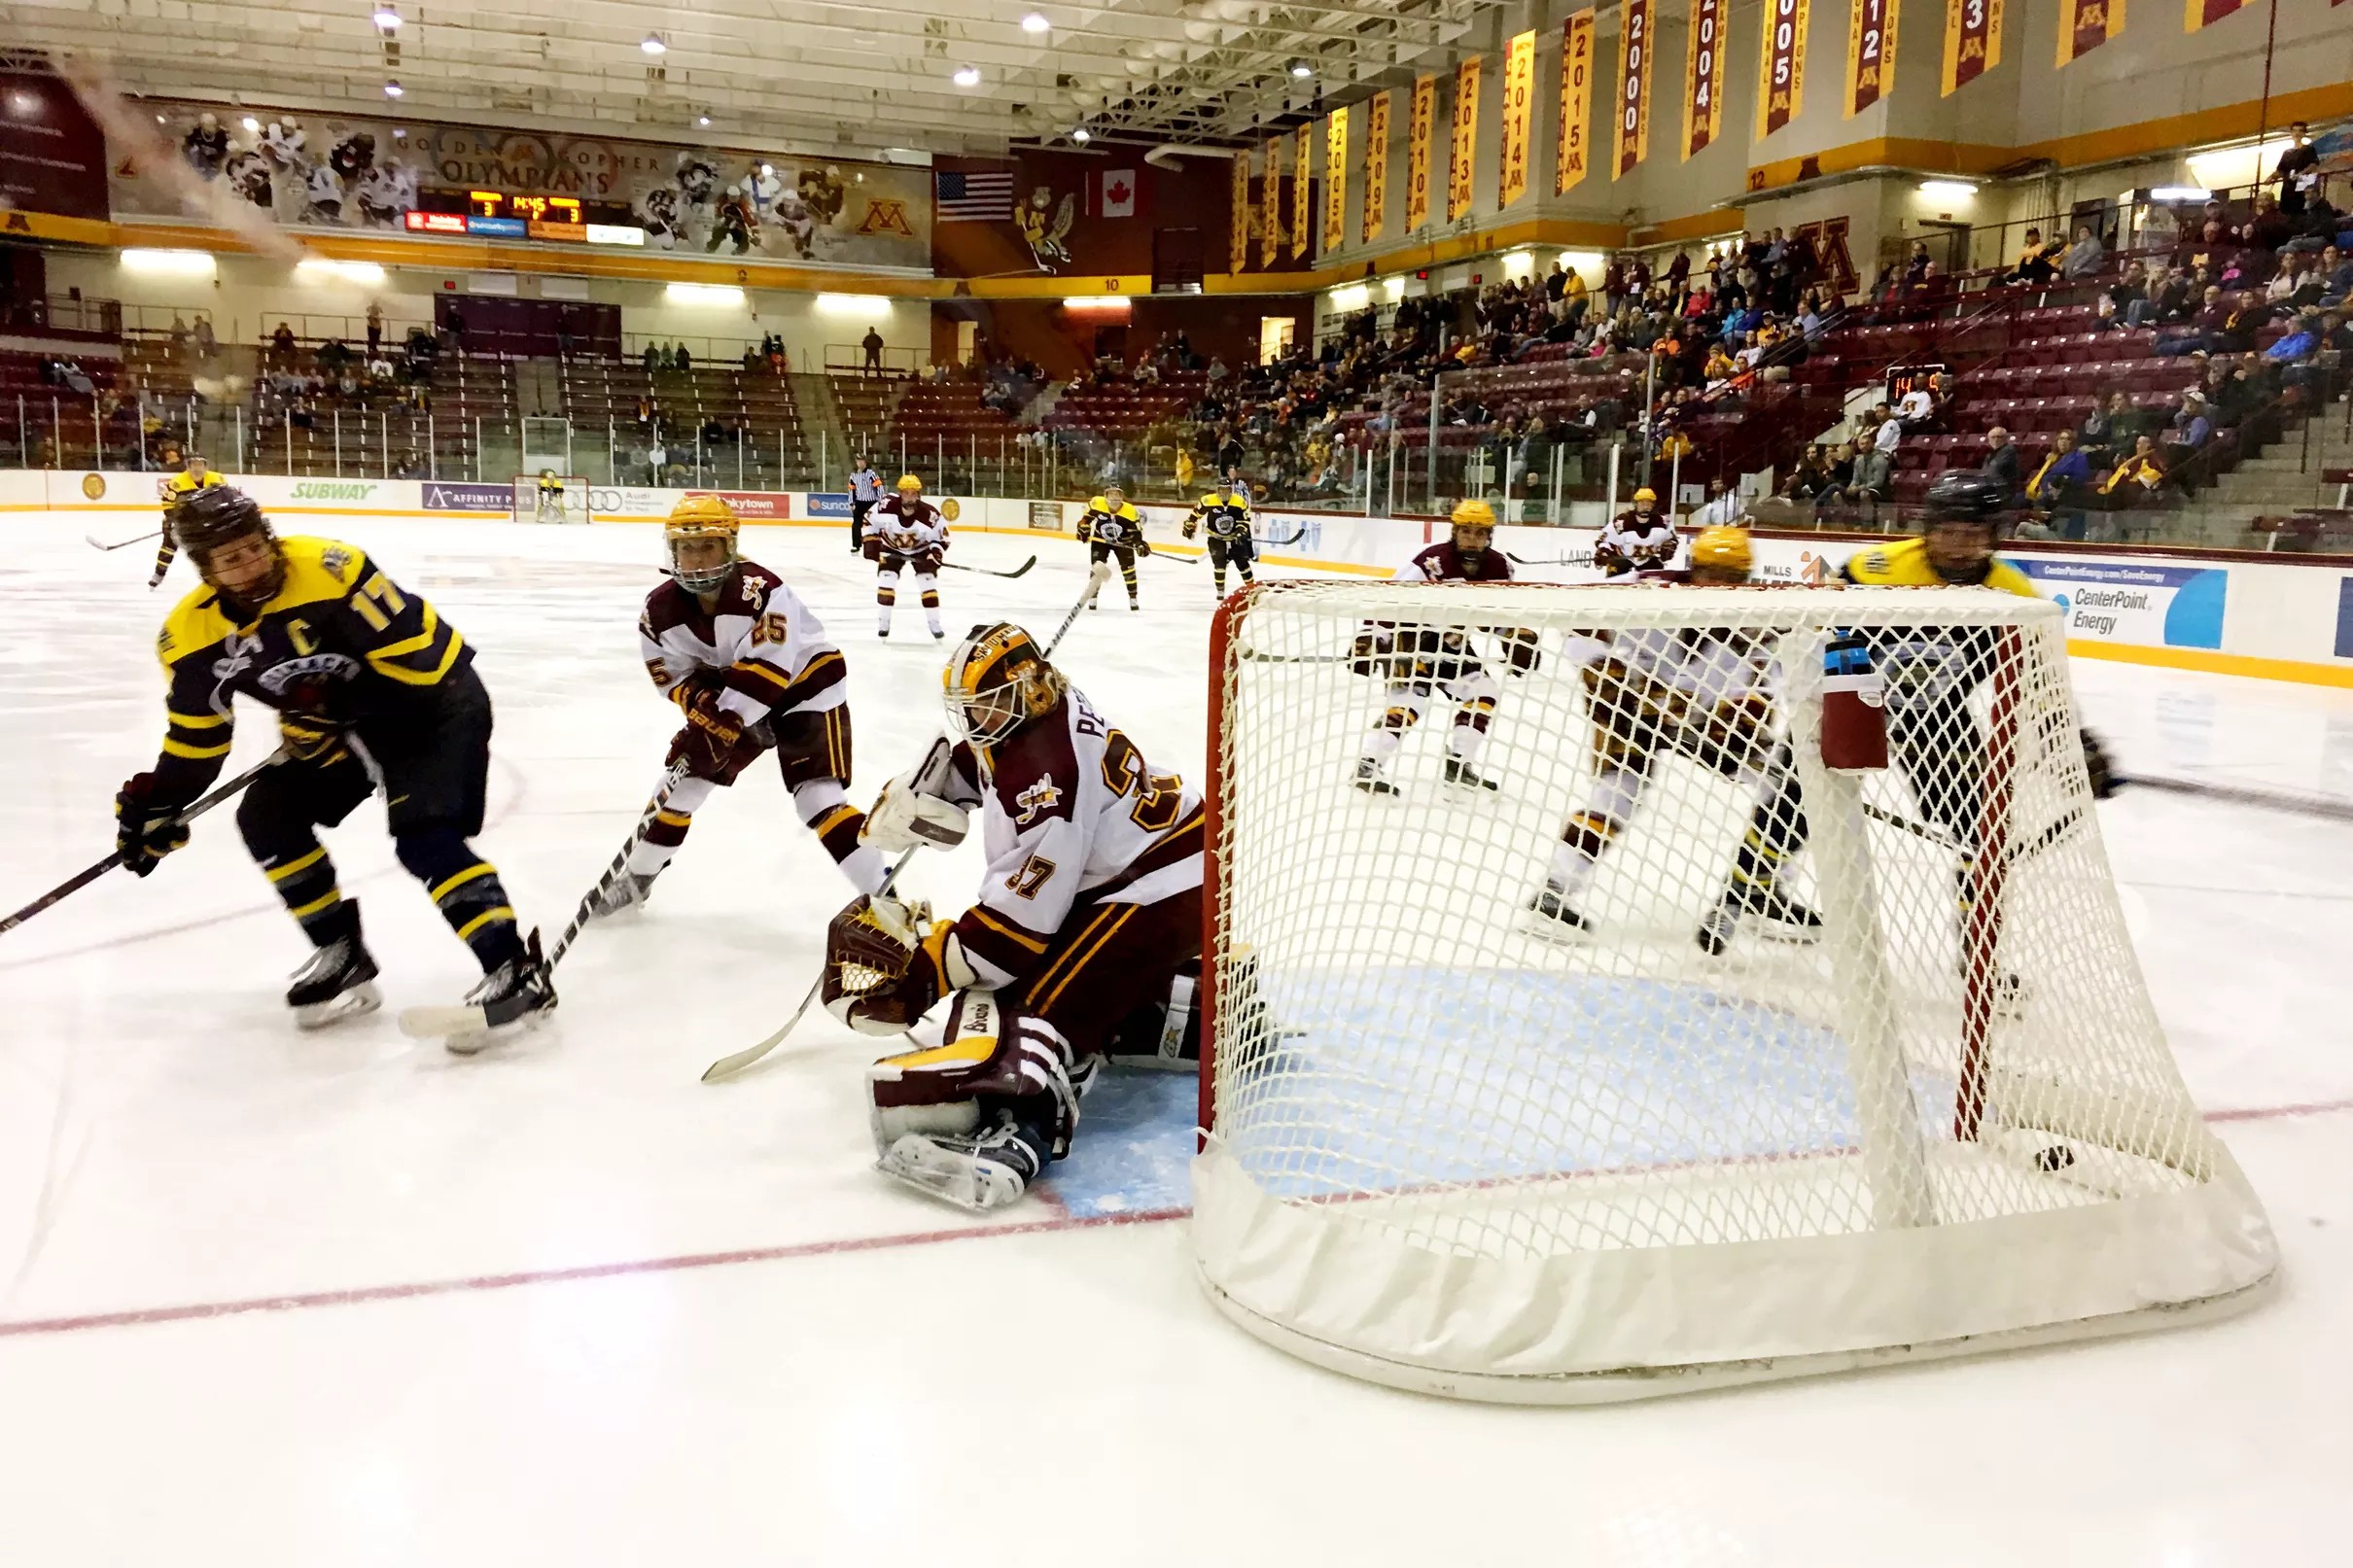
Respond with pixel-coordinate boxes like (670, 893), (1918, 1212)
(638, 562), (850, 724)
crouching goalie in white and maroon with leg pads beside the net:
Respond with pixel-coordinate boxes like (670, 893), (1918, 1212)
(824, 623), (1203, 1208)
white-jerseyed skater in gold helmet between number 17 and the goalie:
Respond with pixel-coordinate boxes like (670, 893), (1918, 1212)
(590, 496), (883, 915)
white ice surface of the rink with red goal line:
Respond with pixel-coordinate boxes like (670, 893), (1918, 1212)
(0, 517), (2353, 1568)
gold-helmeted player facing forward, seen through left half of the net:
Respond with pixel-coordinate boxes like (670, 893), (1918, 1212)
(1349, 501), (1536, 794)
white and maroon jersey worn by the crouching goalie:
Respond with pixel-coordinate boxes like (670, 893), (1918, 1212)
(941, 691), (1205, 985)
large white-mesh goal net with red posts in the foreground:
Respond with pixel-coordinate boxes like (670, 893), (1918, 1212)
(1193, 583), (2275, 1404)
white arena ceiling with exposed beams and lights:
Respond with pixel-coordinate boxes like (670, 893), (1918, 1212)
(0, 0), (1529, 156)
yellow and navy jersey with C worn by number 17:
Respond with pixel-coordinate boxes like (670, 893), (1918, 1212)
(156, 534), (473, 799)
